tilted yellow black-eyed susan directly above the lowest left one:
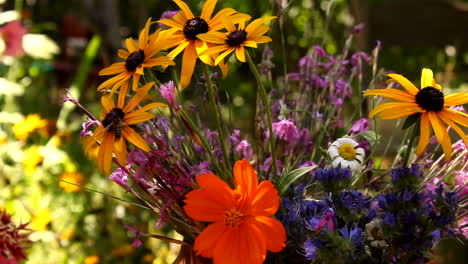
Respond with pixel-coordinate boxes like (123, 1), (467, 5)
(97, 18), (174, 93)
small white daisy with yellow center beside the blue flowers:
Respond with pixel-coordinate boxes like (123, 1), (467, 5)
(328, 138), (365, 171)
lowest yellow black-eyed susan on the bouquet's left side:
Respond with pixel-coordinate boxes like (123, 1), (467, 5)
(84, 82), (166, 175)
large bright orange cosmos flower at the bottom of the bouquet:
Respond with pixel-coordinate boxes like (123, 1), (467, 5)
(184, 159), (286, 264)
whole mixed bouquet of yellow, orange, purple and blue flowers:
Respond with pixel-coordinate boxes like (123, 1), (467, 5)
(67, 0), (468, 264)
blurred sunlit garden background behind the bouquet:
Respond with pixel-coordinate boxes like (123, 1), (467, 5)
(0, 0), (468, 264)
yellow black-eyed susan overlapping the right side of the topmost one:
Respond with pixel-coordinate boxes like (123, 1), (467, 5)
(198, 17), (276, 65)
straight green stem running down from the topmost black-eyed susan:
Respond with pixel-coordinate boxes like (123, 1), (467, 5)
(202, 64), (231, 175)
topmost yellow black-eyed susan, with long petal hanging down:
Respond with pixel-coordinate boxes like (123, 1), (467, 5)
(157, 0), (250, 88)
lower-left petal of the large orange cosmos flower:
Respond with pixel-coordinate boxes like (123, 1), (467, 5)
(194, 222), (226, 258)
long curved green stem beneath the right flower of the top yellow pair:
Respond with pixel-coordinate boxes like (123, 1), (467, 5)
(245, 50), (278, 181)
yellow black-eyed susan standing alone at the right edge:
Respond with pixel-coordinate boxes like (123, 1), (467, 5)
(364, 69), (468, 161)
